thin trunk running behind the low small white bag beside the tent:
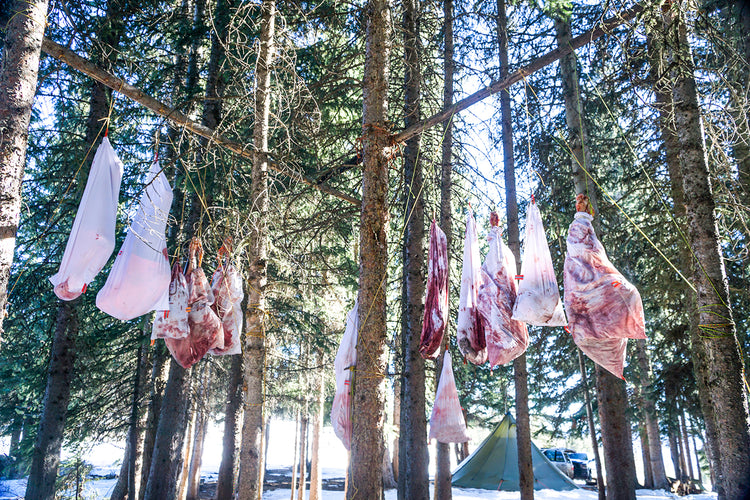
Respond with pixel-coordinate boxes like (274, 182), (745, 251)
(434, 0), (455, 500)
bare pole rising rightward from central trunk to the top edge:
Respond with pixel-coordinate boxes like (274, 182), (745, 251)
(393, 0), (651, 143)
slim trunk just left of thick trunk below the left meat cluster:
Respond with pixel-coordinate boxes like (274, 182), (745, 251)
(138, 342), (170, 500)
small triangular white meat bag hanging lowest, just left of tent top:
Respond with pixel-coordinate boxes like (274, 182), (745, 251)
(429, 351), (469, 443)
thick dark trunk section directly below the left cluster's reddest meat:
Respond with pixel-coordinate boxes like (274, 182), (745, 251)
(143, 363), (190, 500)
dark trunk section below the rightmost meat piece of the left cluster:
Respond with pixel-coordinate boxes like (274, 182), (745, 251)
(216, 356), (242, 500)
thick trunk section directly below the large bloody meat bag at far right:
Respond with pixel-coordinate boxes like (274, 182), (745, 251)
(596, 365), (638, 500)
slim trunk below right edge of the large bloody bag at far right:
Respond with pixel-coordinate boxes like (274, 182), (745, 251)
(635, 339), (669, 490)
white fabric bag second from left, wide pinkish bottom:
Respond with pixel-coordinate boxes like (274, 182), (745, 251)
(96, 162), (172, 321)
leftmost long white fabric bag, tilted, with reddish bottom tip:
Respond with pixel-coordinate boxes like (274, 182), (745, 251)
(49, 137), (123, 300)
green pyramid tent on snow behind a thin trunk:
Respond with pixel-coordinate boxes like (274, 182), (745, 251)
(452, 413), (578, 491)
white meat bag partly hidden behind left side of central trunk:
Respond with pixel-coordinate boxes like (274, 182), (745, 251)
(331, 301), (359, 450)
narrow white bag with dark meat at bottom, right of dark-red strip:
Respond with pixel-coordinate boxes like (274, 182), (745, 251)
(456, 211), (487, 365)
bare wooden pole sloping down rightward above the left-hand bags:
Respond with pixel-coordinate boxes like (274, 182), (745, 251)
(42, 37), (362, 207)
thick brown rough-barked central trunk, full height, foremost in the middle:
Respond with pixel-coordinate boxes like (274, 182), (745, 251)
(346, 0), (392, 500)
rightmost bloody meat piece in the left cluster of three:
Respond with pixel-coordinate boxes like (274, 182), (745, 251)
(209, 252), (244, 356)
